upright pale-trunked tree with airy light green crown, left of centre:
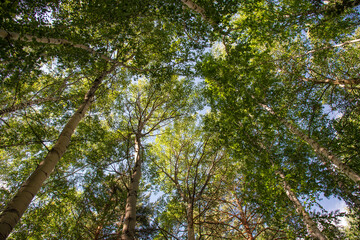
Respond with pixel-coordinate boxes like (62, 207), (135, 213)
(104, 76), (196, 239)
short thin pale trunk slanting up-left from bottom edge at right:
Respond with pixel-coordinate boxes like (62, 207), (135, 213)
(276, 171), (327, 240)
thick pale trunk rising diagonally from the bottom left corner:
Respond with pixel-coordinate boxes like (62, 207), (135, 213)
(0, 64), (117, 240)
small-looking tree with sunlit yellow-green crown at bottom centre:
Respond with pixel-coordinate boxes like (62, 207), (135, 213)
(151, 119), (229, 239)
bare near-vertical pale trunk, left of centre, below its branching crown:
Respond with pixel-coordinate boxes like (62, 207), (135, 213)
(121, 134), (142, 240)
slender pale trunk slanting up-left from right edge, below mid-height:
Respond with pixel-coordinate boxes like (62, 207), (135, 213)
(259, 103), (360, 185)
